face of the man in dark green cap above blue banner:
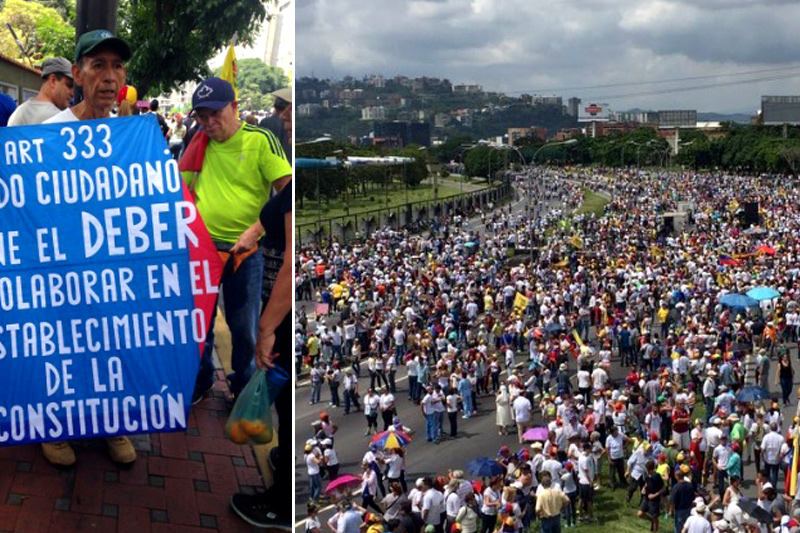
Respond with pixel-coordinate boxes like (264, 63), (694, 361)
(72, 48), (127, 111)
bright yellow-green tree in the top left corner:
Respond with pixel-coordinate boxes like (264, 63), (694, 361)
(0, 0), (75, 66)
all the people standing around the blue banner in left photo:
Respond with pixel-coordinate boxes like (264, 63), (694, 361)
(0, 30), (294, 530)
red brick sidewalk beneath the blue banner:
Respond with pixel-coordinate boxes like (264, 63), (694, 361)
(0, 320), (269, 533)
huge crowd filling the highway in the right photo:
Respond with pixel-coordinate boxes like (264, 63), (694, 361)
(295, 170), (800, 533)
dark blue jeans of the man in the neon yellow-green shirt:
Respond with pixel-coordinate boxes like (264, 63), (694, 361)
(195, 247), (264, 396)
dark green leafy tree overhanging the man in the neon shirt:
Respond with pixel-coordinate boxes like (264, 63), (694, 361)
(118, 0), (274, 97)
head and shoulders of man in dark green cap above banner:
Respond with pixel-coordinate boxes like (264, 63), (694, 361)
(45, 30), (131, 124)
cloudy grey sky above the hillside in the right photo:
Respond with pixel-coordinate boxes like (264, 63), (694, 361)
(296, 0), (800, 113)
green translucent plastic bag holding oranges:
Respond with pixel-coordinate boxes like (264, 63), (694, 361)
(225, 370), (272, 444)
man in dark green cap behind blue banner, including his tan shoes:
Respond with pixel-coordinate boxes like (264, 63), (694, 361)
(42, 30), (136, 466)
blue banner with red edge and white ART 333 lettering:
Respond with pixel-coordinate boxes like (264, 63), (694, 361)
(0, 115), (222, 445)
